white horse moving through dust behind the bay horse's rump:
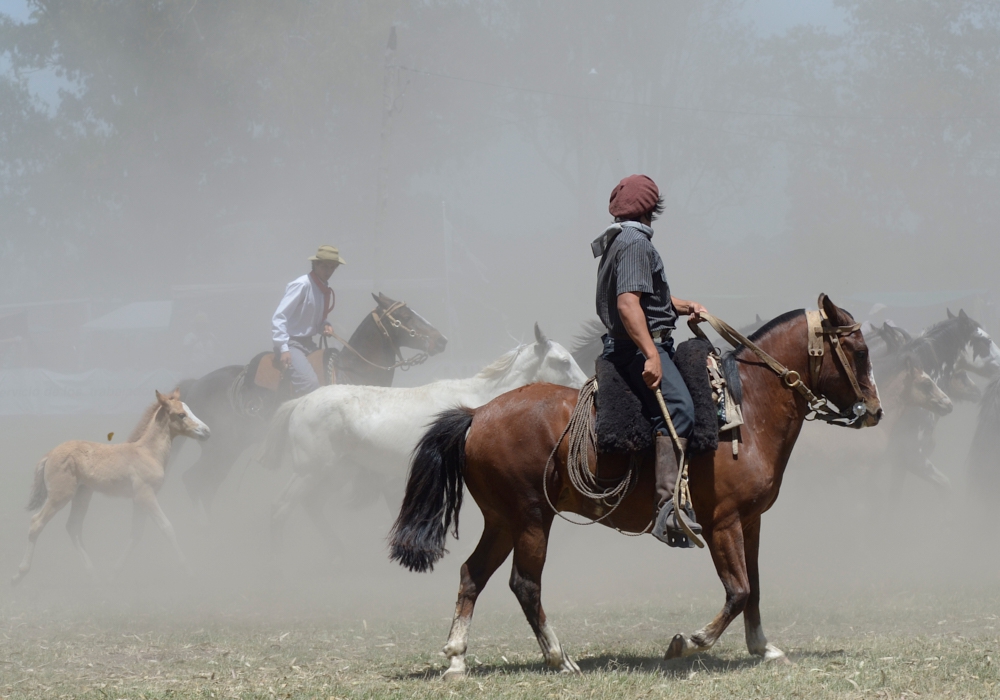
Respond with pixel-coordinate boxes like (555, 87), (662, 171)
(260, 324), (587, 554)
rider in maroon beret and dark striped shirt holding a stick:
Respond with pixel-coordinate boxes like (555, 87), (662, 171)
(593, 175), (706, 547)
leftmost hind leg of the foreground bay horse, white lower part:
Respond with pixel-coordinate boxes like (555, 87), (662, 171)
(444, 520), (514, 678)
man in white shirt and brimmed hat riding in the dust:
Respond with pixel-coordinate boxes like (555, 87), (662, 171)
(271, 245), (344, 396)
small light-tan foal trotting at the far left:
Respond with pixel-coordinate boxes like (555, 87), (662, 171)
(11, 389), (210, 586)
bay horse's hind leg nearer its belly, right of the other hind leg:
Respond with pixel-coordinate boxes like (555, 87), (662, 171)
(510, 516), (580, 673)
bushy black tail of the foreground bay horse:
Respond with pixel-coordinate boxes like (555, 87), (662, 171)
(389, 407), (475, 571)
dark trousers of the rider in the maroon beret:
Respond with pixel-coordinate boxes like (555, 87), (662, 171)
(601, 335), (694, 438)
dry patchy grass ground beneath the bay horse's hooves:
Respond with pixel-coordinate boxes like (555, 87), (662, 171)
(0, 590), (1000, 700)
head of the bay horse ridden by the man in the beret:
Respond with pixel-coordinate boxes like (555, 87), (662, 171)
(816, 294), (882, 428)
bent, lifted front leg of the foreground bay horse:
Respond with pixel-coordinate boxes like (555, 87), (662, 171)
(664, 514), (750, 659)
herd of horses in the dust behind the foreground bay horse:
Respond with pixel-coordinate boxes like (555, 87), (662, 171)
(13, 302), (1000, 584)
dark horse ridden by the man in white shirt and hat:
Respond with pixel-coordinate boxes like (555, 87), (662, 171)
(180, 293), (448, 512)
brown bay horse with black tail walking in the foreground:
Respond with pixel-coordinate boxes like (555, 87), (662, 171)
(390, 298), (882, 675)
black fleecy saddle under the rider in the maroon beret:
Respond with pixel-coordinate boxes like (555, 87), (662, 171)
(594, 338), (743, 454)
